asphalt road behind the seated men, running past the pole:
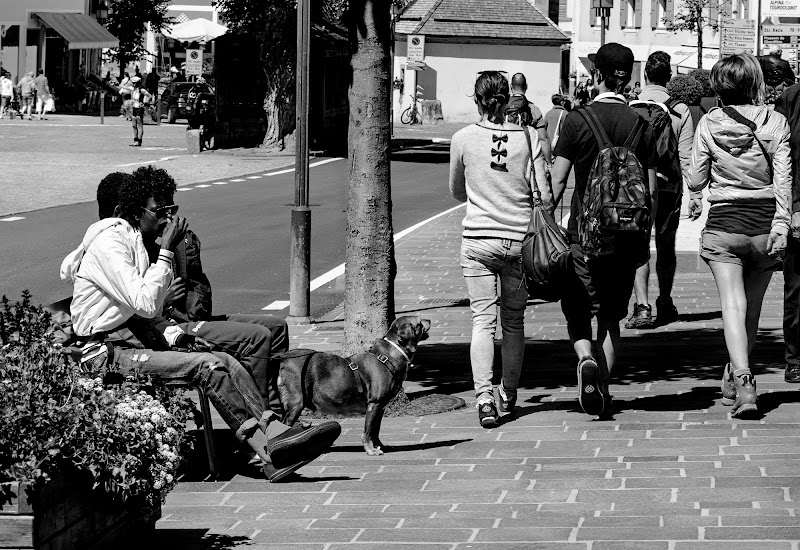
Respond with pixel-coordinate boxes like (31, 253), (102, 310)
(0, 144), (458, 317)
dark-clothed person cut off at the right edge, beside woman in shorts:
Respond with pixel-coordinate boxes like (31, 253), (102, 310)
(759, 56), (800, 384)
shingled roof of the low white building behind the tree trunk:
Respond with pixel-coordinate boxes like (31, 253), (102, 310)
(395, 0), (569, 43)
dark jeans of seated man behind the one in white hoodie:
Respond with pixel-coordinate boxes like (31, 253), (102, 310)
(179, 315), (289, 415)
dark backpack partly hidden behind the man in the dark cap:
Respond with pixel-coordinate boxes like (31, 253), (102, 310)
(628, 98), (683, 194)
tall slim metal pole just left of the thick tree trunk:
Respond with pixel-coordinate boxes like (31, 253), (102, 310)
(289, 0), (311, 322)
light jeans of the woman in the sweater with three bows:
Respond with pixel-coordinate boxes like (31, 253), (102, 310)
(461, 237), (528, 402)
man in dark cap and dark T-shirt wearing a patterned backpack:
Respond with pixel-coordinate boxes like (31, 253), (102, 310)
(551, 42), (657, 417)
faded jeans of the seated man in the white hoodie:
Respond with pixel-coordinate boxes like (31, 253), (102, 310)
(113, 347), (272, 441)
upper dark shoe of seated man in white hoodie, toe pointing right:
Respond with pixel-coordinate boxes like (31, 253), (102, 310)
(267, 421), (342, 468)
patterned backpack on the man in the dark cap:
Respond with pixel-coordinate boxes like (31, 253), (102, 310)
(578, 106), (651, 261)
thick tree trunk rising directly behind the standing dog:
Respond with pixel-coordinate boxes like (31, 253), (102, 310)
(343, 0), (396, 355)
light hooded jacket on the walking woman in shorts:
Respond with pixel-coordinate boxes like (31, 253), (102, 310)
(689, 105), (792, 235)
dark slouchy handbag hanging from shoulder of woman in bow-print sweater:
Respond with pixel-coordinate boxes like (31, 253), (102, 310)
(522, 127), (572, 302)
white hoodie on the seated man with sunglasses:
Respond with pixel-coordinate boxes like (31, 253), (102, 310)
(61, 218), (172, 337)
